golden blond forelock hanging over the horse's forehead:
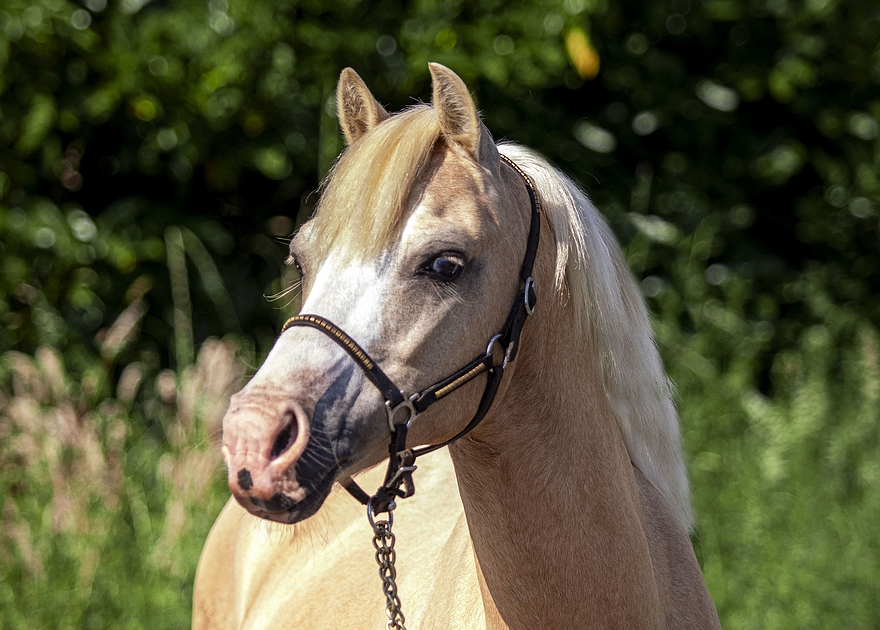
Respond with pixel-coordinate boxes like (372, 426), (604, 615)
(312, 105), (440, 260)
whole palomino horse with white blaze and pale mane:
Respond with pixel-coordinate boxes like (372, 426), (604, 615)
(193, 63), (720, 630)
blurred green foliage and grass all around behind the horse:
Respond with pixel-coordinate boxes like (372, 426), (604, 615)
(0, 0), (880, 628)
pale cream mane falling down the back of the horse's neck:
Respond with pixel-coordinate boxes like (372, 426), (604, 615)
(498, 143), (693, 529)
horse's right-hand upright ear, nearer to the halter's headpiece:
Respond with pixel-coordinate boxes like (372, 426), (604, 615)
(428, 63), (498, 168)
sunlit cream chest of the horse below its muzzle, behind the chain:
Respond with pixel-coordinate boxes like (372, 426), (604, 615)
(213, 450), (486, 630)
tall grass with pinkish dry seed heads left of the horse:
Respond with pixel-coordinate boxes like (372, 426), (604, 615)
(0, 334), (245, 629)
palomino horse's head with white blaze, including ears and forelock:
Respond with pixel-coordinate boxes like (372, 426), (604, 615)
(223, 64), (530, 523)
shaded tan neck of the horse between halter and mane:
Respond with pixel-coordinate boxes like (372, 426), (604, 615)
(450, 283), (661, 628)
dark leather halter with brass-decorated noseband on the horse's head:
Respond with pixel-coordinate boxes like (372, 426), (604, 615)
(281, 155), (541, 519)
